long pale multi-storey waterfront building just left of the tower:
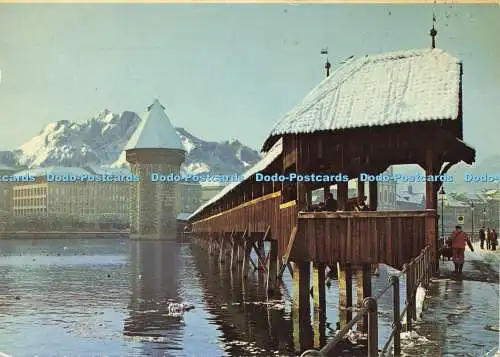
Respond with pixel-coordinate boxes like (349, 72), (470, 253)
(12, 166), (131, 224)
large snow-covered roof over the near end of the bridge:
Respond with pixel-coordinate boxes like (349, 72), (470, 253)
(263, 49), (461, 150)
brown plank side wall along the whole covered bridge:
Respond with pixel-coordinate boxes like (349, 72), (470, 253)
(189, 192), (436, 268)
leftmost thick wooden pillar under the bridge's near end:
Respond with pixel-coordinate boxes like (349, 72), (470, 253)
(292, 262), (312, 352)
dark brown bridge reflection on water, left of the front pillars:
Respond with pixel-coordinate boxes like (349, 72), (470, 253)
(192, 246), (294, 356)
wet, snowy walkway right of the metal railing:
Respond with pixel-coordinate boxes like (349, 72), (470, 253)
(403, 244), (500, 357)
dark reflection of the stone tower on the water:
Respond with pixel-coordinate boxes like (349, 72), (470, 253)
(124, 241), (184, 356)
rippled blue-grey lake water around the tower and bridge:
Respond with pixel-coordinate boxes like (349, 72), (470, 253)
(0, 239), (498, 357)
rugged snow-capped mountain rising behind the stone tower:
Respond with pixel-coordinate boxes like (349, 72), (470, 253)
(6, 109), (260, 174)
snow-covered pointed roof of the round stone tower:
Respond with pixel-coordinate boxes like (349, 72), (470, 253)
(125, 99), (184, 150)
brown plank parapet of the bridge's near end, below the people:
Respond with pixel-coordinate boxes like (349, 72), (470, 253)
(291, 210), (436, 269)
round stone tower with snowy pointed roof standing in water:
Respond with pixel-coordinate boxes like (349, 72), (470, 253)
(125, 100), (186, 239)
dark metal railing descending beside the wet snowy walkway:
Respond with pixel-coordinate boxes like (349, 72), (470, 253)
(301, 246), (433, 357)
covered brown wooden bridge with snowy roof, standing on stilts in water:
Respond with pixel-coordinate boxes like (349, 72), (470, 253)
(189, 49), (475, 350)
